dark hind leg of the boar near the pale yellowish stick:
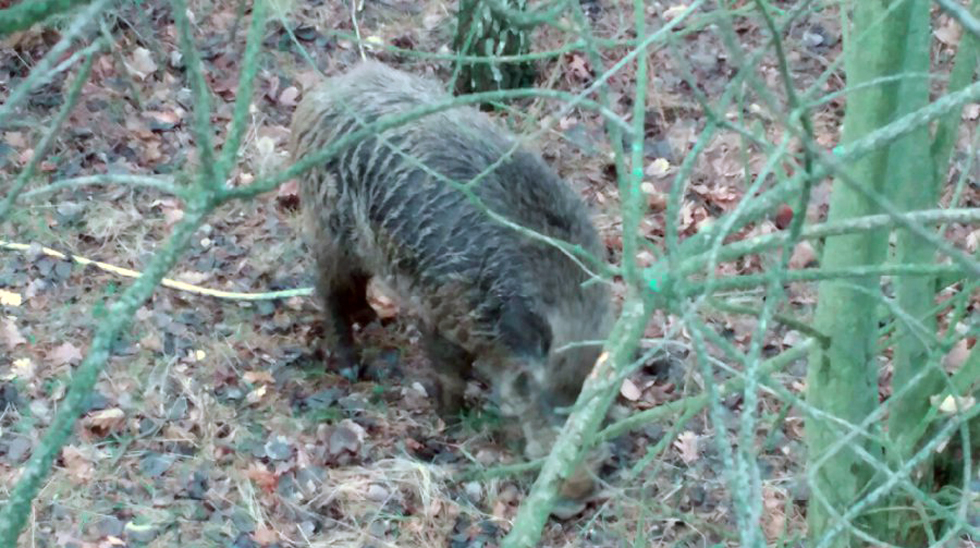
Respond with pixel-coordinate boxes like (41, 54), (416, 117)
(317, 261), (377, 371)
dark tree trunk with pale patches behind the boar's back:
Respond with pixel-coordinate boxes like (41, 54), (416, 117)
(453, 0), (534, 94)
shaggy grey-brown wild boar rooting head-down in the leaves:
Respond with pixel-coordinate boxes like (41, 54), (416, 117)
(290, 62), (611, 478)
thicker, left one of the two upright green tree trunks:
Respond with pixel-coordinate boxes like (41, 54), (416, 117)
(806, 0), (907, 547)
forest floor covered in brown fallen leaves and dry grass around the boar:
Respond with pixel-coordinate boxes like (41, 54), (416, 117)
(0, 0), (980, 548)
